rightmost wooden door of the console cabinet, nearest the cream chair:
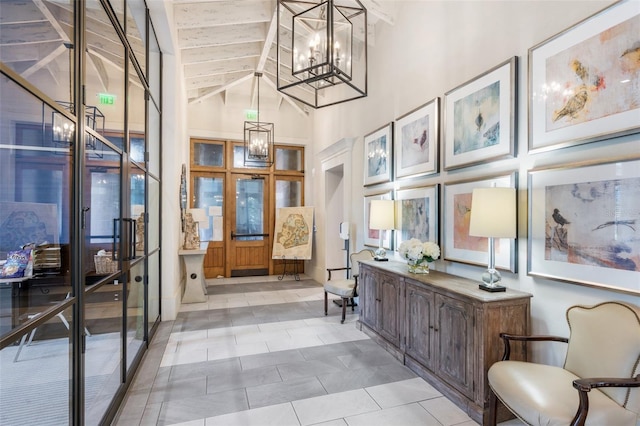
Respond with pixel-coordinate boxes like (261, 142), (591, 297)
(434, 294), (474, 398)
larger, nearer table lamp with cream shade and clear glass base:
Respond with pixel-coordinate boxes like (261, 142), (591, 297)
(469, 187), (516, 292)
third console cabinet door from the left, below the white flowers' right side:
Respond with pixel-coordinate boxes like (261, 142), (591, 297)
(405, 283), (434, 370)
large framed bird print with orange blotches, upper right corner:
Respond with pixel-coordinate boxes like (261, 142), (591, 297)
(529, 1), (640, 152)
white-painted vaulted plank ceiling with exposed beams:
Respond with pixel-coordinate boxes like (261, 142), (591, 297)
(0, 0), (393, 113)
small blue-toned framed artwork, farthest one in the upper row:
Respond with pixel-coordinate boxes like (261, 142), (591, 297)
(364, 123), (393, 186)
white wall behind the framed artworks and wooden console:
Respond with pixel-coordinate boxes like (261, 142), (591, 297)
(313, 1), (640, 363)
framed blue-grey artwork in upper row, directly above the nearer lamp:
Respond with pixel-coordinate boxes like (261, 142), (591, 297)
(444, 56), (518, 169)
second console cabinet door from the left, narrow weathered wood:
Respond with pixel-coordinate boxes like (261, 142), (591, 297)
(378, 274), (400, 347)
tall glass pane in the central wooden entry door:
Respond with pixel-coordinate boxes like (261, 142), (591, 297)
(235, 179), (264, 241)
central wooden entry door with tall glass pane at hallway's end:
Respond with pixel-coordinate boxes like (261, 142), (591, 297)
(225, 173), (272, 277)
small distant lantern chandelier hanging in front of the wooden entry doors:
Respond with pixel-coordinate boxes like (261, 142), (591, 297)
(244, 72), (273, 167)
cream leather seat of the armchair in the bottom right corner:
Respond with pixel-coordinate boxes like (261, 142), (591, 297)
(488, 361), (638, 426)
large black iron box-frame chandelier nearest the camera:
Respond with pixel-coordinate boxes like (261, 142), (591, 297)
(277, 0), (367, 108)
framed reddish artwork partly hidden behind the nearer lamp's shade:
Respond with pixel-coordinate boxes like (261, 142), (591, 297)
(442, 172), (518, 273)
